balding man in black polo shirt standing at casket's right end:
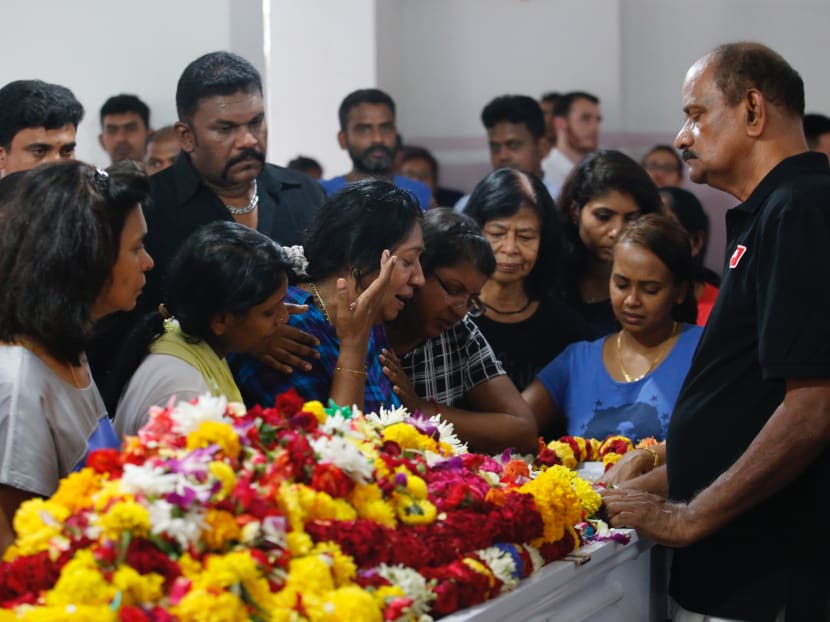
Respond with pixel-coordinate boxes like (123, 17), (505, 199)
(604, 43), (830, 621)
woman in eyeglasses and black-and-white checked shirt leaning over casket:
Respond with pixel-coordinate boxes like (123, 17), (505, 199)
(380, 208), (537, 452)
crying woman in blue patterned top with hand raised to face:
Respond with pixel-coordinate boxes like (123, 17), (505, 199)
(234, 180), (424, 412)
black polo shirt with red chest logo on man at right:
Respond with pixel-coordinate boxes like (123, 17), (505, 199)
(667, 153), (830, 620)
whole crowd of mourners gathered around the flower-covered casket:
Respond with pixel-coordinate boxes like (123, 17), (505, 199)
(0, 44), (830, 620)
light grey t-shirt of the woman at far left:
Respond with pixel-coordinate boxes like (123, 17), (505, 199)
(0, 345), (117, 496)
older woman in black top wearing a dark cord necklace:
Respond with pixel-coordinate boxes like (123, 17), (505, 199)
(464, 168), (590, 391)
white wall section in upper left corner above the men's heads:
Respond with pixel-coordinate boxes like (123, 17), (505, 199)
(0, 0), (234, 165)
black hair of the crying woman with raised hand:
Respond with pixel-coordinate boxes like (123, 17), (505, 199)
(303, 179), (423, 281)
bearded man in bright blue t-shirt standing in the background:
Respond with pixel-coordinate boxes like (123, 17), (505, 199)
(320, 89), (432, 210)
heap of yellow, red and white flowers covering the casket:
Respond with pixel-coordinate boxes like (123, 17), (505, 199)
(0, 392), (600, 622)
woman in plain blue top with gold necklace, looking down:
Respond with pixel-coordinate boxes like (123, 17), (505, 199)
(523, 214), (702, 440)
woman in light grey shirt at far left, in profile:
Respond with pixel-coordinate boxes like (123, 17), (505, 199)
(0, 162), (153, 552)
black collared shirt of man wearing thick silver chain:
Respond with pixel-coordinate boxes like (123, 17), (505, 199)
(140, 152), (325, 309)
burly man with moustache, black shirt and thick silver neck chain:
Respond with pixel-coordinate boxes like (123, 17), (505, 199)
(88, 52), (325, 405)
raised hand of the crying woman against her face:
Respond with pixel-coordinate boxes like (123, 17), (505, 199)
(335, 250), (398, 343)
